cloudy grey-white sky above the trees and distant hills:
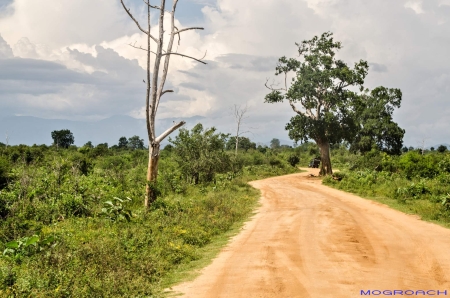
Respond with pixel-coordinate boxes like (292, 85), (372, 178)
(0, 0), (450, 147)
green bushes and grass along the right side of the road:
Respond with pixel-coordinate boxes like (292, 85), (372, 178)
(323, 146), (450, 226)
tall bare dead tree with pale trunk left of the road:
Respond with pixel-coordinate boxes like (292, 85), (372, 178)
(120, 0), (206, 208)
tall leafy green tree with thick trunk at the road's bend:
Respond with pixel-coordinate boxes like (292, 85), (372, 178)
(265, 32), (403, 175)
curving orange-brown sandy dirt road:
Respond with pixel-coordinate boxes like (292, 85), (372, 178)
(169, 169), (450, 298)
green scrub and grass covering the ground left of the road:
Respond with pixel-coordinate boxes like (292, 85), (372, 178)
(0, 125), (302, 297)
